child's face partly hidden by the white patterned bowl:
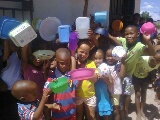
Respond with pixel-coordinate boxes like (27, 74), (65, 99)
(106, 49), (117, 65)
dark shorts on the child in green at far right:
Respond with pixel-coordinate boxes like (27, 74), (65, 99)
(132, 76), (150, 86)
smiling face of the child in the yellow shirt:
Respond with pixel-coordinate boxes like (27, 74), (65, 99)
(77, 44), (90, 61)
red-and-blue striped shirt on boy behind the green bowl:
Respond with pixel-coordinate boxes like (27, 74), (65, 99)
(44, 69), (77, 120)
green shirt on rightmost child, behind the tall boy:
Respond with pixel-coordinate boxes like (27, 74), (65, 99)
(134, 56), (160, 78)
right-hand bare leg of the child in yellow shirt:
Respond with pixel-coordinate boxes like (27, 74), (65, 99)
(84, 104), (96, 120)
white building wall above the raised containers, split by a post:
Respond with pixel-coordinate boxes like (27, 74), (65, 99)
(34, 0), (110, 24)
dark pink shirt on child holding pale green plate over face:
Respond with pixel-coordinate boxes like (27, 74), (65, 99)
(23, 64), (45, 100)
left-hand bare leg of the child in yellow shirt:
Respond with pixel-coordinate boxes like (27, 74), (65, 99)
(76, 104), (83, 120)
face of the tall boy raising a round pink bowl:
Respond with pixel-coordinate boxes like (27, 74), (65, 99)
(124, 27), (139, 44)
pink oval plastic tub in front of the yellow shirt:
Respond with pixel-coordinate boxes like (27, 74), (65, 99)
(68, 68), (95, 80)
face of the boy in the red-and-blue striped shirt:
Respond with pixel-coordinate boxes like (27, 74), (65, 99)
(56, 56), (71, 72)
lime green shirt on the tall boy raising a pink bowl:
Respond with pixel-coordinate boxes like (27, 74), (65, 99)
(117, 38), (145, 76)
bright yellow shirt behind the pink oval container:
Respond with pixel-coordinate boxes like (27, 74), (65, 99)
(76, 60), (96, 98)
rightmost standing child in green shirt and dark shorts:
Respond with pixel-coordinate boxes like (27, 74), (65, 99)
(133, 46), (160, 120)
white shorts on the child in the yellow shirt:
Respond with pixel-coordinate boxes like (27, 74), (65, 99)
(75, 96), (97, 107)
